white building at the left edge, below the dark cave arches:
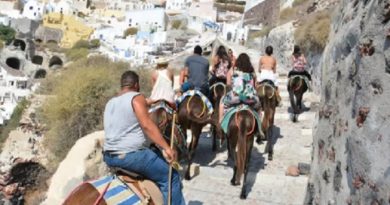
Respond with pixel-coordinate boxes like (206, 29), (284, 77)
(0, 65), (31, 125)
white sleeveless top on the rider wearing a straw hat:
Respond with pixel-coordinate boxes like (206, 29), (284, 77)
(150, 69), (175, 103)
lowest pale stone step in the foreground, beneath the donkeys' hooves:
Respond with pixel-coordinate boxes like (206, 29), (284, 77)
(183, 166), (308, 204)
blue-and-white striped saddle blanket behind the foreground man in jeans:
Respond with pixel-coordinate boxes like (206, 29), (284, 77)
(89, 176), (142, 205)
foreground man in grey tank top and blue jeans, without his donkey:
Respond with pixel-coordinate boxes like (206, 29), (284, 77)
(103, 71), (185, 205)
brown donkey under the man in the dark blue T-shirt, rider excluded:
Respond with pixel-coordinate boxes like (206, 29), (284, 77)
(178, 95), (221, 180)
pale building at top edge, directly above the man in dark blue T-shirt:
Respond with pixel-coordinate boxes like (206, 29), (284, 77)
(188, 0), (218, 33)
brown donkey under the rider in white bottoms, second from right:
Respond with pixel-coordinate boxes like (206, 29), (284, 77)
(256, 82), (278, 160)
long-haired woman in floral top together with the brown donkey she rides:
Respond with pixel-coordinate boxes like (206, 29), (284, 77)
(219, 53), (261, 198)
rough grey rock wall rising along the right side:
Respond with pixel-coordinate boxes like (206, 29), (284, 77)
(306, 0), (390, 204)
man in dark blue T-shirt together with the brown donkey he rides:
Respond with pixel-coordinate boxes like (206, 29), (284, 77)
(176, 46), (219, 180)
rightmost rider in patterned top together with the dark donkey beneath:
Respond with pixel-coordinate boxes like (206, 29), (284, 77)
(287, 45), (311, 122)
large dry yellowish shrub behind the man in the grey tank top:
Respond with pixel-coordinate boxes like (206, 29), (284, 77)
(41, 56), (150, 166)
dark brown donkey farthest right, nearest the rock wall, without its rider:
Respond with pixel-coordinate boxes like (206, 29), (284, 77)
(287, 75), (309, 122)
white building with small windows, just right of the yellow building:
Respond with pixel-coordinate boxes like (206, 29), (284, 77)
(124, 8), (166, 32)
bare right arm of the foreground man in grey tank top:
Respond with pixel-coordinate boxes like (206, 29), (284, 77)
(132, 95), (176, 162)
